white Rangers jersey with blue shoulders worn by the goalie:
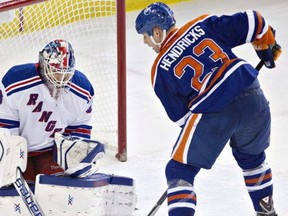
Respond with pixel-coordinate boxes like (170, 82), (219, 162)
(0, 63), (94, 152)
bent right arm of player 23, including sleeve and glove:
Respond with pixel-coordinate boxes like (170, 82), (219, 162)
(206, 10), (281, 68)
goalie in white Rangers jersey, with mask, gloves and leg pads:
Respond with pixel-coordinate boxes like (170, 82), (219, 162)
(0, 39), (135, 216)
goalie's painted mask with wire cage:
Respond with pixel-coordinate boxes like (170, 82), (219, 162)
(39, 40), (75, 96)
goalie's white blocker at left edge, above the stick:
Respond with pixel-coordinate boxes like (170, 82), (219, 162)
(0, 129), (27, 187)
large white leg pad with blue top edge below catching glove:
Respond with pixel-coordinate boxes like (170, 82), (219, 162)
(35, 173), (136, 216)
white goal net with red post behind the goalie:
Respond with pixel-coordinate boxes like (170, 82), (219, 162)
(0, 0), (127, 161)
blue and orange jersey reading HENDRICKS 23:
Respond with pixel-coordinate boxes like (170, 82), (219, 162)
(151, 10), (275, 125)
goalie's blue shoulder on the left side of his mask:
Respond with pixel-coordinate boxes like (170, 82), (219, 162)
(2, 63), (41, 87)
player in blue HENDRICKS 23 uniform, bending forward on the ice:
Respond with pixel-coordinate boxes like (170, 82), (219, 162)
(136, 2), (281, 216)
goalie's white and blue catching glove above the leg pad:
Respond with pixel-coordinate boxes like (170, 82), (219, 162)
(54, 133), (104, 178)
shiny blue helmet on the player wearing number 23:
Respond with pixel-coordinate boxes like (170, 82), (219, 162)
(135, 2), (176, 36)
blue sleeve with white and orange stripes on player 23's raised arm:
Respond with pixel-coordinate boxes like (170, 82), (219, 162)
(206, 10), (272, 48)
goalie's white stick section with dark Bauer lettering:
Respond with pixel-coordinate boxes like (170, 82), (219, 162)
(13, 167), (44, 216)
